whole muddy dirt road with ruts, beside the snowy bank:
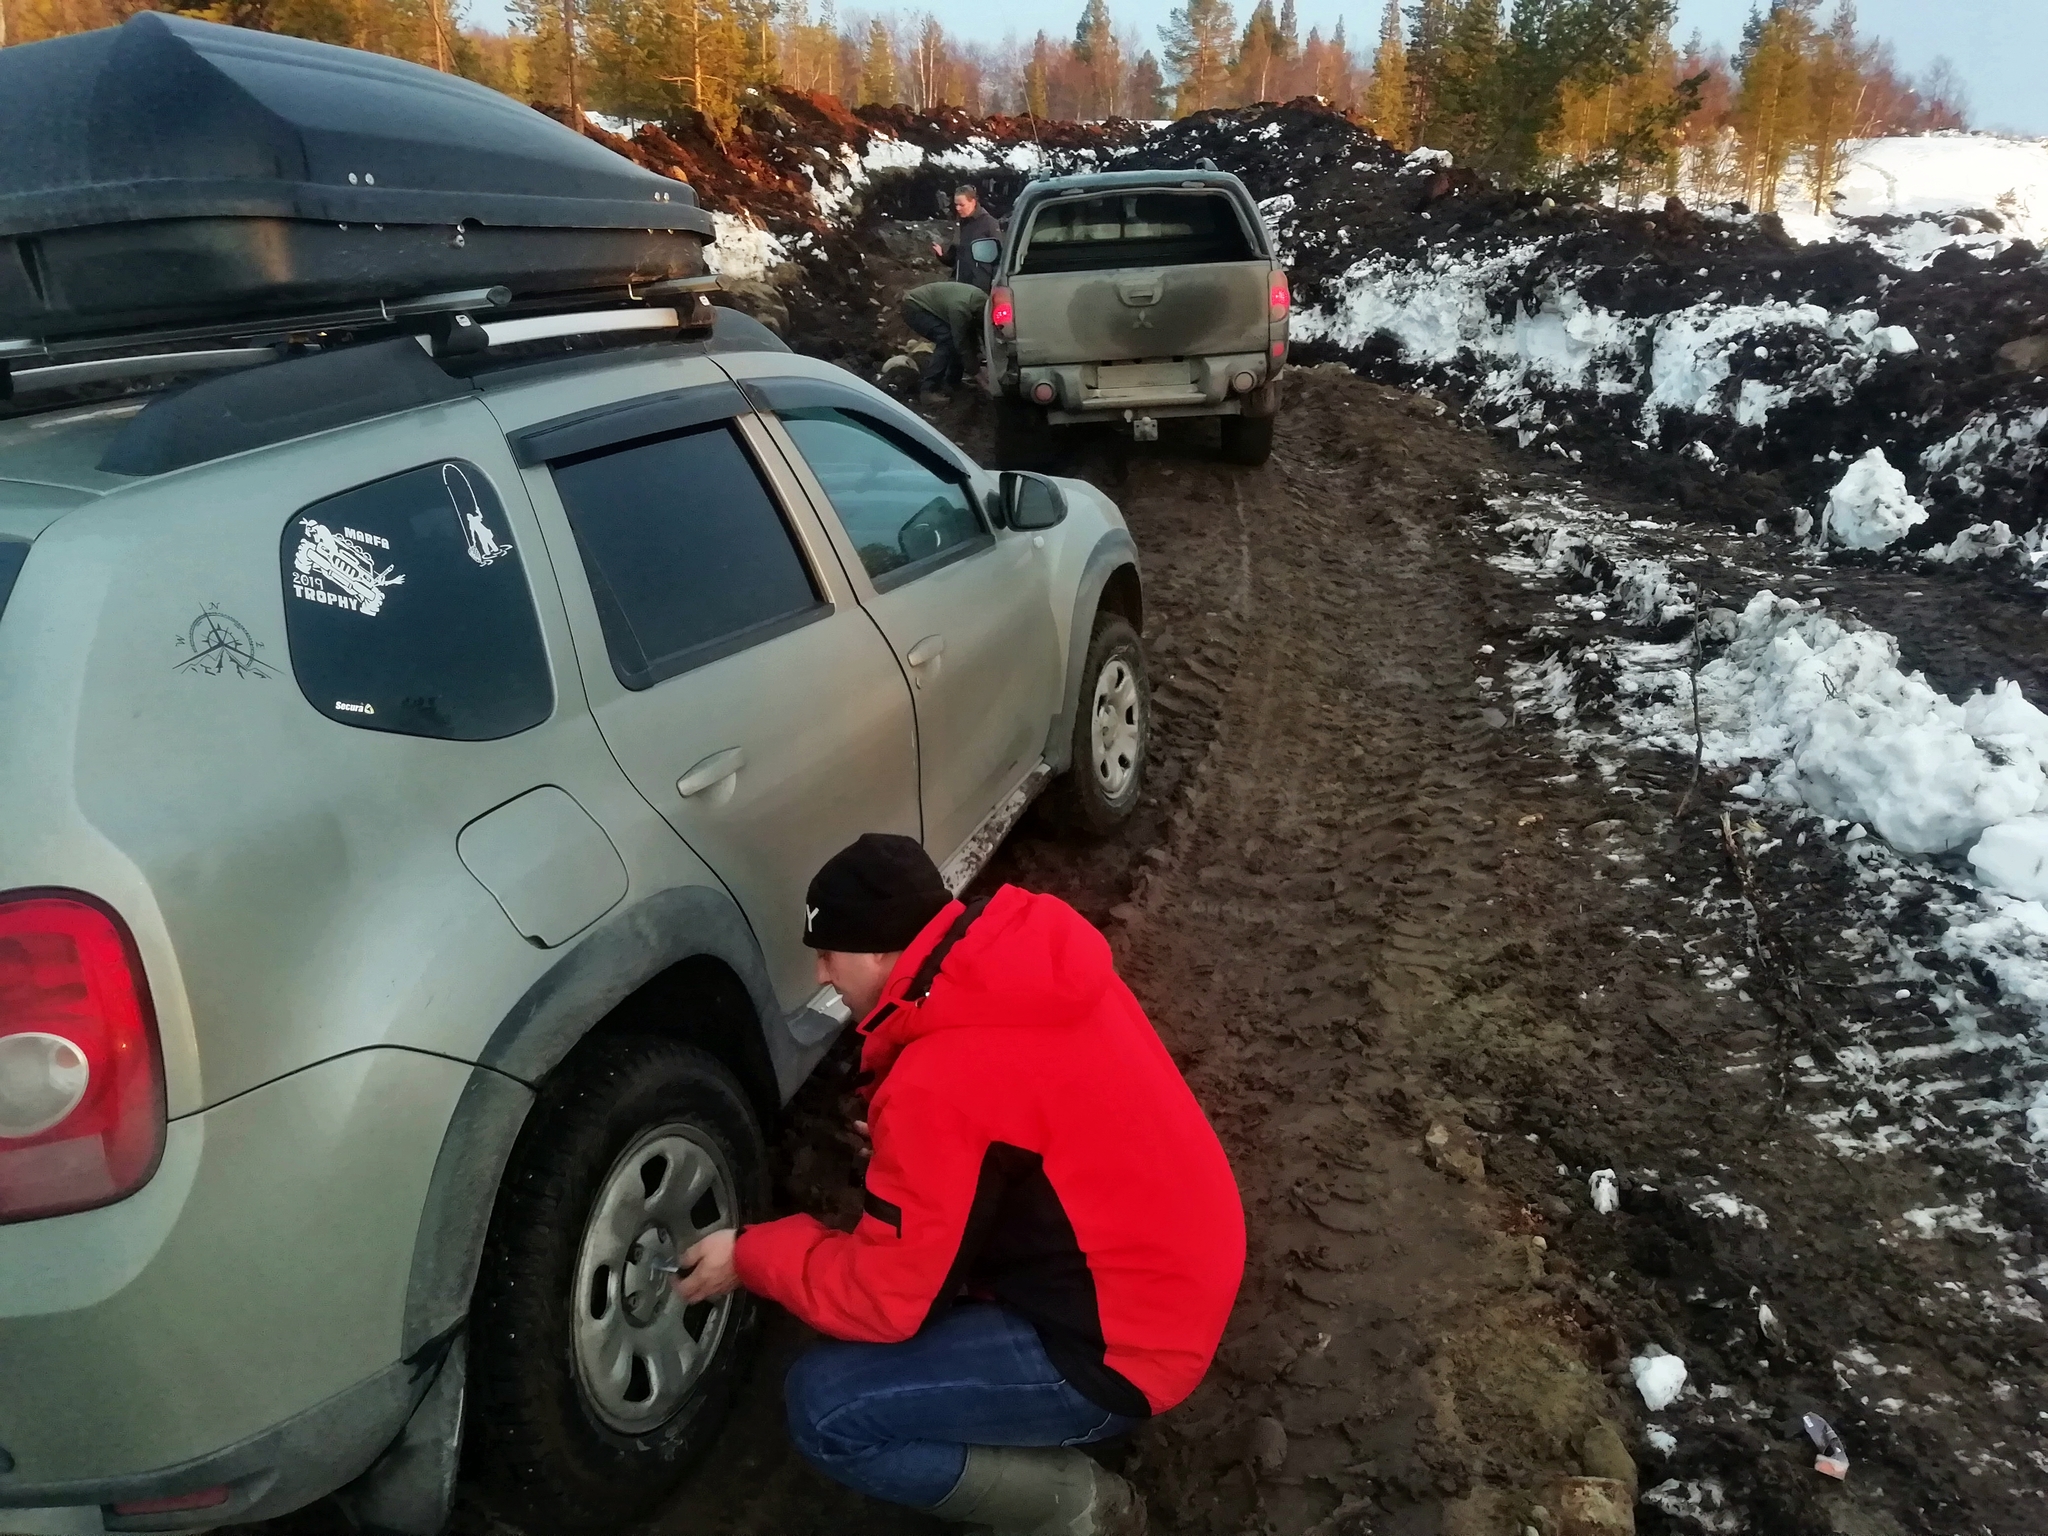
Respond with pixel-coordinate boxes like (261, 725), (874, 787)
(260, 369), (2048, 1536)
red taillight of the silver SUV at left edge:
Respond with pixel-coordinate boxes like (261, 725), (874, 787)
(0, 891), (164, 1223)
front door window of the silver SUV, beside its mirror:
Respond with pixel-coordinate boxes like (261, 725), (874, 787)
(776, 406), (987, 590)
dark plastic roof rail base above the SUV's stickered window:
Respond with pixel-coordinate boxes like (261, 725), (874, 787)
(98, 336), (471, 475)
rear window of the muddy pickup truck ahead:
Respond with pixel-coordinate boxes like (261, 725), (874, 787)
(1014, 193), (1260, 276)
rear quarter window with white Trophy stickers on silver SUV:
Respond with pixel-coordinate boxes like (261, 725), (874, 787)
(279, 459), (555, 741)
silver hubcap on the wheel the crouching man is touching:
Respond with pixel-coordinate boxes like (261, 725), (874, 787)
(569, 1124), (737, 1434)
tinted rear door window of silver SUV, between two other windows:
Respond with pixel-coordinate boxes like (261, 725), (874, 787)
(553, 422), (831, 688)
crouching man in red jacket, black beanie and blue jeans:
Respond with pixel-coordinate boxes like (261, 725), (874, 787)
(676, 834), (1245, 1536)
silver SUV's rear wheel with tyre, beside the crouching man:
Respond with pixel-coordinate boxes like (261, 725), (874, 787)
(467, 1036), (768, 1532)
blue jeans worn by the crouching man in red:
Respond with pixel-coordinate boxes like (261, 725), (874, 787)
(784, 1303), (1133, 1509)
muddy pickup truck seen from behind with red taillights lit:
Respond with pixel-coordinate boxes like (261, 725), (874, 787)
(973, 162), (1292, 469)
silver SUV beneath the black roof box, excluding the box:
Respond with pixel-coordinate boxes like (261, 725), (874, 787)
(0, 311), (1149, 1534)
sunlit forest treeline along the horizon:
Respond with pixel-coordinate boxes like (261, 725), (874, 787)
(0, 0), (1966, 211)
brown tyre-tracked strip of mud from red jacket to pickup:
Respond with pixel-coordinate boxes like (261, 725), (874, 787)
(1116, 379), (1608, 1532)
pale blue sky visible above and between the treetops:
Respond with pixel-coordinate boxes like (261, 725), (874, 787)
(469, 0), (2048, 137)
